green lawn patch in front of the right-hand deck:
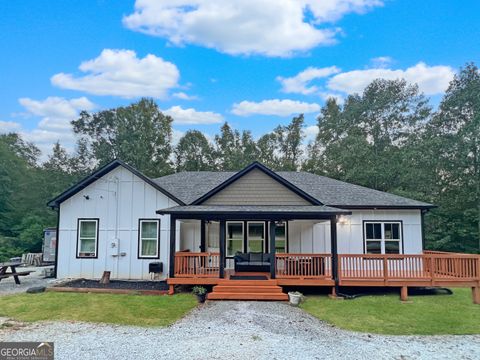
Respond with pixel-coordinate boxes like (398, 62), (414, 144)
(300, 289), (480, 335)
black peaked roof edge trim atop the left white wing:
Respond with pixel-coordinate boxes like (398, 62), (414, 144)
(47, 159), (185, 208)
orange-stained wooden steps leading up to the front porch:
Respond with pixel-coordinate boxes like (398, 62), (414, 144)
(207, 279), (288, 301)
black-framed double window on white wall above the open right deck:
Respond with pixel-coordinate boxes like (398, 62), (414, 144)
(364, 221), (402, 254)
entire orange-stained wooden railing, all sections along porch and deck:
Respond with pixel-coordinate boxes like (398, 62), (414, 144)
(174, 252), (480, 285)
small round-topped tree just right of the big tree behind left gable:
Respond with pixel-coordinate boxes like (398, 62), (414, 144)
(175, 130), (214, 171)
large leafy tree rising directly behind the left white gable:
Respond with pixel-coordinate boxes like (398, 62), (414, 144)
(72, 99), (173, 177)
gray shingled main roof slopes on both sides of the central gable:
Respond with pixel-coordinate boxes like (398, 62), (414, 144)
(153, 171), (433, 208)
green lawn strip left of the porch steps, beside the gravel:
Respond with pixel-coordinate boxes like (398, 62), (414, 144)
(0, 292), (197, 326)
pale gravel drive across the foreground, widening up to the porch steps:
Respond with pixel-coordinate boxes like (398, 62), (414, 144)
(0, 302), (480, 360)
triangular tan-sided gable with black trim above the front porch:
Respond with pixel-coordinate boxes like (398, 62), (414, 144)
(191, 162), (323, 205)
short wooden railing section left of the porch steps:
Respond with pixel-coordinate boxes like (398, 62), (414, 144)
(175, 252), (220, 278)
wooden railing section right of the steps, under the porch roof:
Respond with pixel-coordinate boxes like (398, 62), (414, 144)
(275, 254), (332, 279)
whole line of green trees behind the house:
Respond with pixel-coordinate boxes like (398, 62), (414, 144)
(0, 63), (480, 258)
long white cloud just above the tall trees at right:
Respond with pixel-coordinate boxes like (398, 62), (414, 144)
(327, 62), (455, 95)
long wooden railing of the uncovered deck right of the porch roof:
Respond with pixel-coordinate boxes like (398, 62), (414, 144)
(338, 253), (480, 281)
